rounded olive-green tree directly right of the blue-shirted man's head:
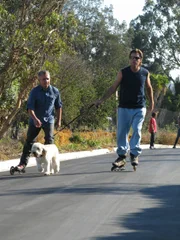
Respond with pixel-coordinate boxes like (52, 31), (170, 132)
(46, 54), (96, 129)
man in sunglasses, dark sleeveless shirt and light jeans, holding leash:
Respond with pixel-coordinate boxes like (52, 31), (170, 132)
(95, 49), (154, 170)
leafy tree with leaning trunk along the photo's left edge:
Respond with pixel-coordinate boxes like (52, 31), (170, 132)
(0, 0), (67, 138)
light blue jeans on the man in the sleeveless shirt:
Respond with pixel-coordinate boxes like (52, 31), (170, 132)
(117, 108), (146, 156)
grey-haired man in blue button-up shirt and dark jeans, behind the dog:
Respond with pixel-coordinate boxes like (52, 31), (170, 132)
(17, 71), (62, 171)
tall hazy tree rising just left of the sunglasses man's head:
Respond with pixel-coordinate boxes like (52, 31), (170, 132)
(62, 0), (132, 127)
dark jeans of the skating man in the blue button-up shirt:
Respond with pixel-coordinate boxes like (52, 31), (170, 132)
(19, 123), (54, 166)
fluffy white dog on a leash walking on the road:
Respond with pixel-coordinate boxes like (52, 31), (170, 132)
(31, 143), (60, 175)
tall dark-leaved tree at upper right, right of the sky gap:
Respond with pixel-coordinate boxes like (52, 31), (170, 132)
(131, 0), (180, 80)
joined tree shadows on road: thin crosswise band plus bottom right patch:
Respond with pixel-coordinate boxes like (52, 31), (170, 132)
(0, 183), (180, 240)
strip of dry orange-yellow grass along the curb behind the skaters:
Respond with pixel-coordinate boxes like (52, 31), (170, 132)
(0, 129), (176, 161)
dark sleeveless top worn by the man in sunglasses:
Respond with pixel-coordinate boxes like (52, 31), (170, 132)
(119, 66), (148, 108)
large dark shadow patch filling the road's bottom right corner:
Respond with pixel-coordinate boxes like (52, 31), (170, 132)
(91, 185), (180, 240)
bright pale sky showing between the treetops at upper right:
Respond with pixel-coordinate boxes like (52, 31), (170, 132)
(104, 0), (180, 78)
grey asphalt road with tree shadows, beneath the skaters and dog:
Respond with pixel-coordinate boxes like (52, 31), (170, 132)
(0, 149), (180, 240)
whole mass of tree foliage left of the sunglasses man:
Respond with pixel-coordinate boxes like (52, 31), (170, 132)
(0, 0), (132, 138)
